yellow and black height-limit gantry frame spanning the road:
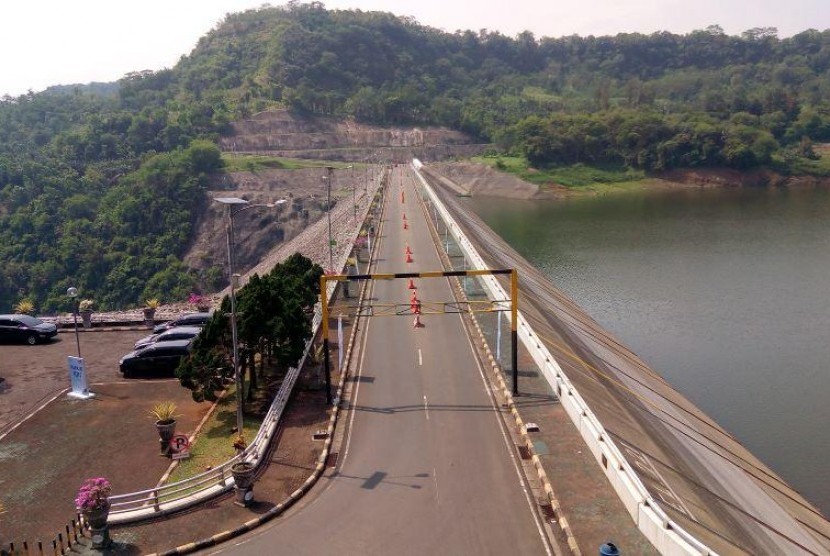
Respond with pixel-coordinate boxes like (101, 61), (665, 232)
(320, 268), (519, 404)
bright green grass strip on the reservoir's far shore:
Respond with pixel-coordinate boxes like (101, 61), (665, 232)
(473, 156), (646, 189)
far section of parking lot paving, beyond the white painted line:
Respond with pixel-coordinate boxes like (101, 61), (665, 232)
(0, 330), (166, 434)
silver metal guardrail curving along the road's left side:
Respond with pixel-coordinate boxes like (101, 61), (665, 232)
(108, 173), (382, 524)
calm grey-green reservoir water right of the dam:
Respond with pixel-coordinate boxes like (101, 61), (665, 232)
(468, 188), (830, 516)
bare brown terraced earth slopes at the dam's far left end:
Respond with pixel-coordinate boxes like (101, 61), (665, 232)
(184, 110), (490, 293)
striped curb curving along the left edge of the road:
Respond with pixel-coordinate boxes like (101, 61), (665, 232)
(149, 175), (385, 556)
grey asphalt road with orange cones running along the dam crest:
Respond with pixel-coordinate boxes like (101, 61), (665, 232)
(214, 170), (551, 555)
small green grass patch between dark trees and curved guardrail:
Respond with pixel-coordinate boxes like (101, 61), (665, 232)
(166, 385), (262, 488)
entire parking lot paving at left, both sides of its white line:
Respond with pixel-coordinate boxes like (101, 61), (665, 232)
(0, 330), (210, 547)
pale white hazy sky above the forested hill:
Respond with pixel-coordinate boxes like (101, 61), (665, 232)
(0, 0), (830, 97)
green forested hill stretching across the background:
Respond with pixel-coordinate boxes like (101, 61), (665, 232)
(0, 3), (830, 312)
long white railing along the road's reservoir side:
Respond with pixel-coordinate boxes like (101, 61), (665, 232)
(412, 160), (715, 555)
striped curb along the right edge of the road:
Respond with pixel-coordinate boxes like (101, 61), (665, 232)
(418, 172), (582, 556)
